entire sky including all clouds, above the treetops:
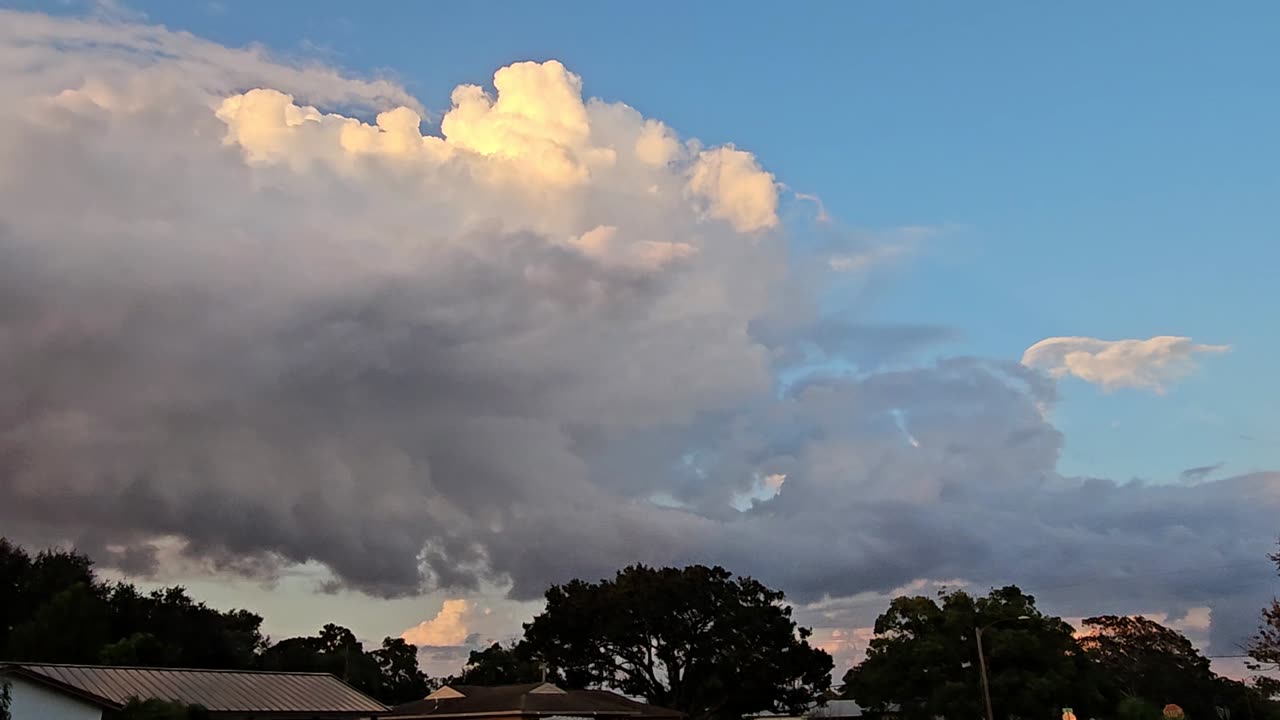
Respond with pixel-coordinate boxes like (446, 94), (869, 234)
(0, 0), (1280, 673)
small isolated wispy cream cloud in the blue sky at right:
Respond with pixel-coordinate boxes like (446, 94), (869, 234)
(1023, 336), (1231, 393)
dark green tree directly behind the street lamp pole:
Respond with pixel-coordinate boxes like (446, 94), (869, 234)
(845, 585), (1100, 720)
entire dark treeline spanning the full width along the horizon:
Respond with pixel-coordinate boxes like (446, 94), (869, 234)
(0, 539), (1280, 720)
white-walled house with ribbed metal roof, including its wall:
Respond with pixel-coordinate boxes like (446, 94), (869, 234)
(0, 662), (387, 720)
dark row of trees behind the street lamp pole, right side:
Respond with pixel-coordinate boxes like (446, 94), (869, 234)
(842, 585), (1280, 720)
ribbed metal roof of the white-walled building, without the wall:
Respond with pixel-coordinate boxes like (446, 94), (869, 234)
(0, 662), (387, 716)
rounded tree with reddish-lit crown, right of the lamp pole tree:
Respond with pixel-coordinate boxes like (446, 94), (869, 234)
(1079, 615), (1219, 717)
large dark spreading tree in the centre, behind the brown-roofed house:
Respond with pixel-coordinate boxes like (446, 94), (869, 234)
(525, 565), (832, 720)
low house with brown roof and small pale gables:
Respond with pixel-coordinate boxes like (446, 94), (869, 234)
(387, 683), (684, 720)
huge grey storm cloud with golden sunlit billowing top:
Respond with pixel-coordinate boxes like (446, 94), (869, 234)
(0, 13), (1280, 666)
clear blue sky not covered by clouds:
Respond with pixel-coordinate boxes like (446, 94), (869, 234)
(0, 0), (1280, 671)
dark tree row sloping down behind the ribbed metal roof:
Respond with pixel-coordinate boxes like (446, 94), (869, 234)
(0, 538), (429, 705)
